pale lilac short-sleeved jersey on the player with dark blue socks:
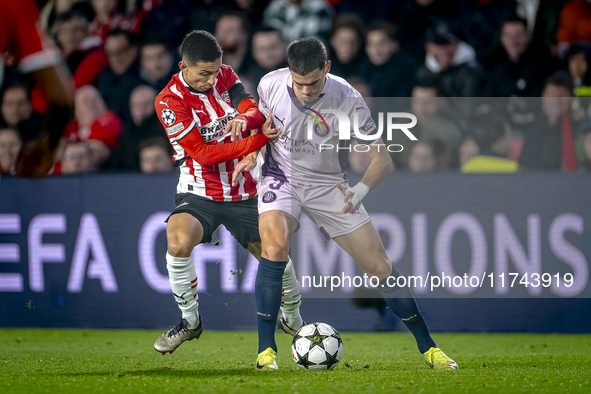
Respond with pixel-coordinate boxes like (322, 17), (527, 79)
(258, 68), (379, 186)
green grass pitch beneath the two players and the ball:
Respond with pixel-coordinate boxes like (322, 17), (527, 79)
(0, 329), (591, 394)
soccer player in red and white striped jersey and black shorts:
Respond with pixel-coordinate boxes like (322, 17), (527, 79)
(154, 30), (300, 354)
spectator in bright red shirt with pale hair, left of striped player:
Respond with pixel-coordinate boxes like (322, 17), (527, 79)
(64, 85), (123, 168)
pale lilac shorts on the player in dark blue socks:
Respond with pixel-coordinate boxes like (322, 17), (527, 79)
(257, 177), (371, 241)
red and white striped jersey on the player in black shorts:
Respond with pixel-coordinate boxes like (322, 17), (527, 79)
(155, 65), (269, 201)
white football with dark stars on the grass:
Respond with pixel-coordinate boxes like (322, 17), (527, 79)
(291, 323), (343, 369)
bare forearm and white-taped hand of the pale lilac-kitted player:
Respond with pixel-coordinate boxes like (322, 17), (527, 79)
(337, 138), (394, 213)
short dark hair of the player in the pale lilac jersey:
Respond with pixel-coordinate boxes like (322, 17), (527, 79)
(287, 38), (328, 75)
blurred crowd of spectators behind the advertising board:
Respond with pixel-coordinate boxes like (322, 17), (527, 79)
(0, 0), (591, 175)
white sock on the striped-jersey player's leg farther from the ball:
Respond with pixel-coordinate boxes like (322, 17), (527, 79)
(166, 252), (199, 330)
